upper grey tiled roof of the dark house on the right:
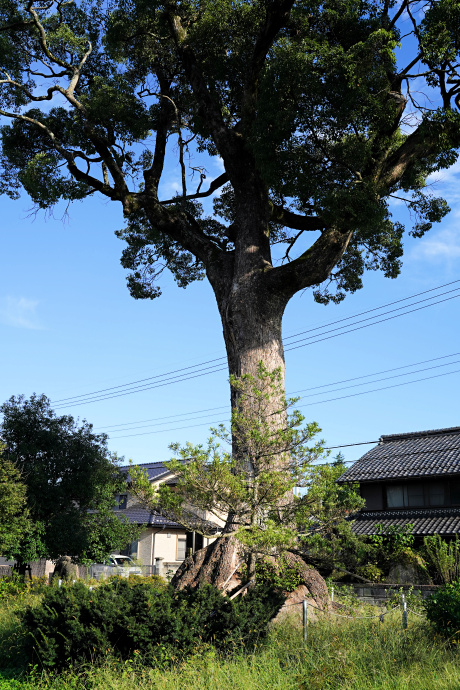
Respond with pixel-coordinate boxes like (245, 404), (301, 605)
(338, 427), (460, 484)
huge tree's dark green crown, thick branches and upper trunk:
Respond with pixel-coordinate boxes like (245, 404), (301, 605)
(0, 0), (460, 580)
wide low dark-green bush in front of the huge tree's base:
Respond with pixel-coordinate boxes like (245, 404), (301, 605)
(23, 578), (284, 670)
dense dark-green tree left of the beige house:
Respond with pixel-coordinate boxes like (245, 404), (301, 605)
(0, 395), (137, 563)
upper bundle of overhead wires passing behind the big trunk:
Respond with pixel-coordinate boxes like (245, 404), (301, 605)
(53, 280), (460, 408)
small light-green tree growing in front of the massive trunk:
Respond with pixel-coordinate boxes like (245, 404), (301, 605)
(131, 363), (363, 579)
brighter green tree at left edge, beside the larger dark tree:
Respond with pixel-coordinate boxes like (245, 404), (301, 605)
(0, 443), (32, 556)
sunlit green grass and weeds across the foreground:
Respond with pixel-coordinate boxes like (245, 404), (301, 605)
(0, 584), (460, 690)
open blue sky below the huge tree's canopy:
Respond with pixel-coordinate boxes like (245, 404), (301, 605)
(0, 148), (460, 463)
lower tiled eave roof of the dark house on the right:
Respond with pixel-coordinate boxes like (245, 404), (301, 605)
(352, 508), (460, 536)
